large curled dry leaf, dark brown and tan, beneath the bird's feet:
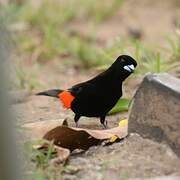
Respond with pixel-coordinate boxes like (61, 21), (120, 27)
(25, 120), (128, 151)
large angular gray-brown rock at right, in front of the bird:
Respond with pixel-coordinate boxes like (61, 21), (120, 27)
(129, 73), (180, 156)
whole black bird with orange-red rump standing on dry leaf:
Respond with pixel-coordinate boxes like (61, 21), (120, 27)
(37, 55), (137, 128)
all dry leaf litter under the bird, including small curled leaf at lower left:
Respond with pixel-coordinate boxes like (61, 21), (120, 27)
(23, 119), (128, 164)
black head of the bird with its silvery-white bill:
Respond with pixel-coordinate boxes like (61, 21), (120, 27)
(112, 55), (137, 79)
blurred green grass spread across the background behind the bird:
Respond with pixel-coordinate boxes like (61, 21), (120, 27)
(3, 0), (180, 83)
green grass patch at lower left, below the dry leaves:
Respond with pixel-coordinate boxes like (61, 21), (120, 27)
(24, 140), (63, 180)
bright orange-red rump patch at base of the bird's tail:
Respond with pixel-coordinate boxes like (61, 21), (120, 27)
(58, 91), (74, 109)
